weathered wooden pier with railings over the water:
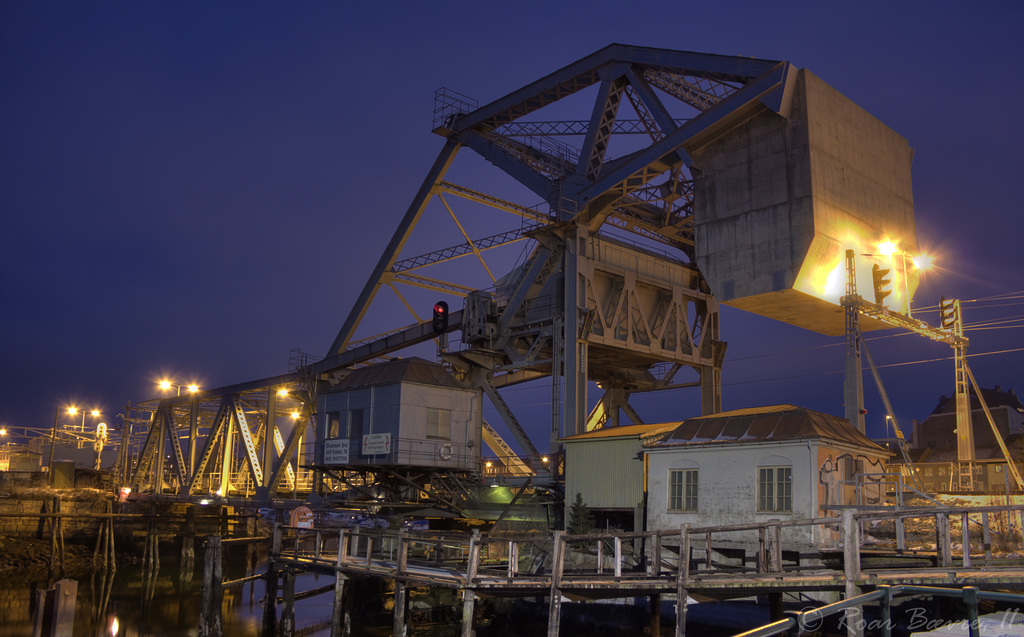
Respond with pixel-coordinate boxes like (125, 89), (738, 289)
(247, 506), (1024, 637)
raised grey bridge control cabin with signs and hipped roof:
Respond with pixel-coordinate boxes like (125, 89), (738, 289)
(317, 357), (481, 471)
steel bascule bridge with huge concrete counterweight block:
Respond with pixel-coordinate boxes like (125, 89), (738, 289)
(135, 44), (966, 512)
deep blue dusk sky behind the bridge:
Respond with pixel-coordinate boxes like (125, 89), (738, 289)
(0, 0), (1024, 448)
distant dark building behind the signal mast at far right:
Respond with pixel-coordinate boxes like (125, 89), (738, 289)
(913, 385), (1024, 462)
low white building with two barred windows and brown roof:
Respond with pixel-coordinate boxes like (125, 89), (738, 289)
(644, 405), (889, 544)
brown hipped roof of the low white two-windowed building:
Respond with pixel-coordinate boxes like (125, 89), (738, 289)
(654, 405), (886, 453)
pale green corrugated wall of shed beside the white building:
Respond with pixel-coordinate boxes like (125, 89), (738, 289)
(565, 436), (643, 520)
